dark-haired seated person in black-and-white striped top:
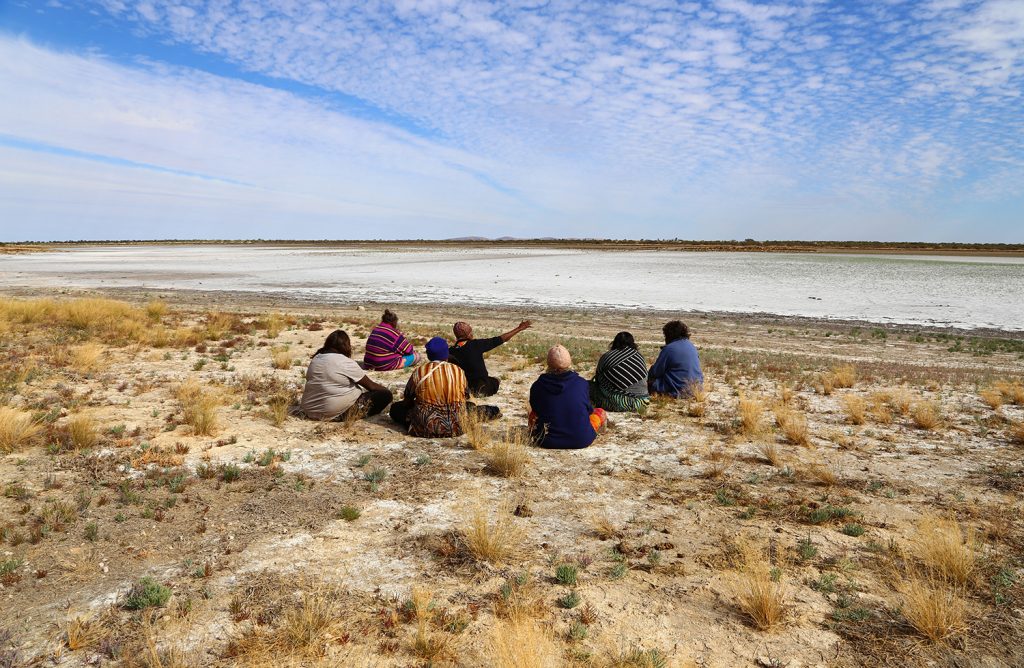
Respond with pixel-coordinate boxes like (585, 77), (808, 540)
(590, 332), (650, 414)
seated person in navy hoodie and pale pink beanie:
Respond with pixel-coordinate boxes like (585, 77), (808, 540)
(529, 345), (608, 449)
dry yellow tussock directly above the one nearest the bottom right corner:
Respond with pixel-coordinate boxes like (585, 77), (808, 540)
(910, 515), (979, 585)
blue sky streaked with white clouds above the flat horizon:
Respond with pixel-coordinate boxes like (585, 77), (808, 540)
(0, 0), (1024, 243)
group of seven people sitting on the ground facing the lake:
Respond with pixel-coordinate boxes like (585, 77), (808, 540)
(300, 309), (703, 449)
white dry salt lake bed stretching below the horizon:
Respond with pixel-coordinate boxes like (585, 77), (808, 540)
(0, 245), (1024, 330)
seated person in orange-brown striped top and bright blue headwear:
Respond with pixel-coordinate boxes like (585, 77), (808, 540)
(390, 336), (501, 439)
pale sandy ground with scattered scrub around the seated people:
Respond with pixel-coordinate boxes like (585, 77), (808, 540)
(0, 294), (1024, 667)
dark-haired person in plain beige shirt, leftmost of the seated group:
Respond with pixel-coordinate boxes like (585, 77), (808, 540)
(299, 329), (393, 420)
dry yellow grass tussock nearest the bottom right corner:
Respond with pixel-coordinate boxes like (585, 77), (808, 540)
(899, 574), (969, 642)
